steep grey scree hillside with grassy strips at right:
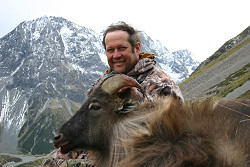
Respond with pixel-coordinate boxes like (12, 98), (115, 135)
(180, 27), (250, 100)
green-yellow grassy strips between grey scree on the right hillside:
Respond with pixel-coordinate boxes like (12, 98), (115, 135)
(179, 27), (250, 98)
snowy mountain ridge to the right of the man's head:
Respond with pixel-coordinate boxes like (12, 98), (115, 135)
(141, 32), (200, 83)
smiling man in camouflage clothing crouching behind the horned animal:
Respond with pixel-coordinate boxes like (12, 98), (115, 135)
(43, 23), (184, 166)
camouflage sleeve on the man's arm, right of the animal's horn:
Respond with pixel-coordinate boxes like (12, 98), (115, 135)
(141, 67), (184, 104)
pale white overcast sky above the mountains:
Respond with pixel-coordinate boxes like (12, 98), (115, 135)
(0, 0), (250, 61)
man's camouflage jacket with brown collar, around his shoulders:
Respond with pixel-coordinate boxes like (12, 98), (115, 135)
(88, 52), (184, 104)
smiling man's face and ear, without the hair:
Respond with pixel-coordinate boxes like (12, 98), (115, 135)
(105, 30), (141, 74)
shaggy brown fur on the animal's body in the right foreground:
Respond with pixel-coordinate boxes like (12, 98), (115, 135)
(119, 98), (250, 167)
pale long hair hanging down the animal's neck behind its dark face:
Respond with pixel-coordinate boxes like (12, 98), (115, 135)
(94, 102), (155, 167)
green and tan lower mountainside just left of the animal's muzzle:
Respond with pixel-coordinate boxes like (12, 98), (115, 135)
(18, 98), (80, 154)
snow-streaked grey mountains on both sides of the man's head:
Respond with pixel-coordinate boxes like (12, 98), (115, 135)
(0, 16), (198, 154)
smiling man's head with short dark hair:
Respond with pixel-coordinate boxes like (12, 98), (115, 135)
(103, 23), (141, 74)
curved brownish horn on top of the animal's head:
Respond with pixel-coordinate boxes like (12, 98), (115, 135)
(101, 74), (141, 94)
